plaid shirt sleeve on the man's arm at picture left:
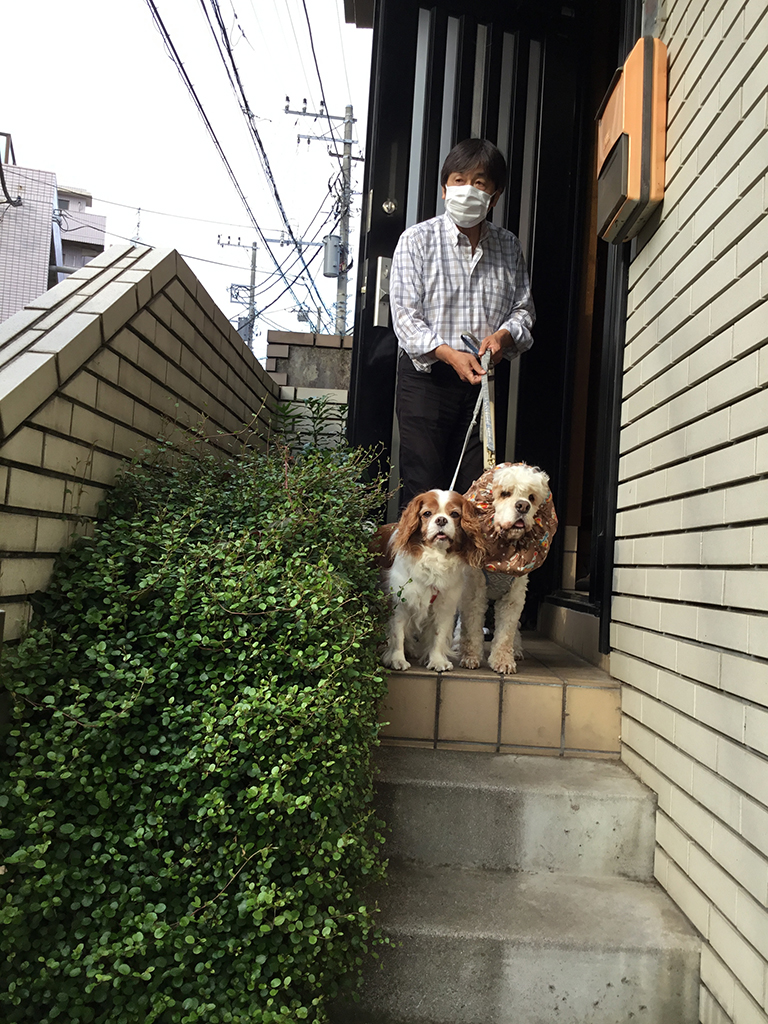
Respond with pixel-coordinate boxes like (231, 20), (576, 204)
(389, 230), (444, 370)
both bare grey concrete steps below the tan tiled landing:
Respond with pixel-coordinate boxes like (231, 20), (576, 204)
(332, 638), (699, 1024)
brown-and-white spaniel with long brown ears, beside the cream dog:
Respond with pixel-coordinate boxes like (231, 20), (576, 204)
(382, 490), (486, 672)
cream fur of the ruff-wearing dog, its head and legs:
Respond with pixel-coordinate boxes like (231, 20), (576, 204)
(459, 465), (549, 675)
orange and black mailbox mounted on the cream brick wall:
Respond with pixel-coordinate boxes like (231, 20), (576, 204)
(596, 36), (667, 243)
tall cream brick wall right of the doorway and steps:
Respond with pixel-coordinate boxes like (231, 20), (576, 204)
(610, 0), (768, 1024)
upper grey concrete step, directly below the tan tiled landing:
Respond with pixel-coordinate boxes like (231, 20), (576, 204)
(376, 748), (655, 880)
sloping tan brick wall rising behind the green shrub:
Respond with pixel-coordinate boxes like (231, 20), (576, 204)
(0, 246), (278, 639)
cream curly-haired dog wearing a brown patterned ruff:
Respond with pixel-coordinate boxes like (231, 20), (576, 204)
(459, 463), (557, 675)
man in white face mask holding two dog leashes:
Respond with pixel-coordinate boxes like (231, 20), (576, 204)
(390, 138), (536, 507)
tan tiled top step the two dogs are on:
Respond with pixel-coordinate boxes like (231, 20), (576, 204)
(380, 632), (621, 759)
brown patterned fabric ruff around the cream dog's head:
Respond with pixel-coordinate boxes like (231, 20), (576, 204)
(464, 462), (557, 582)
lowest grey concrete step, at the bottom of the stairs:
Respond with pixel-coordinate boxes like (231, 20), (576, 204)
(332, 865), (699, 1024)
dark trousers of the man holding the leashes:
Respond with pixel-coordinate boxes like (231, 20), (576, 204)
(397, 350), (483, 509)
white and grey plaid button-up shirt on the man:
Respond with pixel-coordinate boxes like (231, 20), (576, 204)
(389, 214), (536, 373)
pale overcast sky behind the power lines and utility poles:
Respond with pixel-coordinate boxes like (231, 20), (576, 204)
(0, 0), (371, 355)
